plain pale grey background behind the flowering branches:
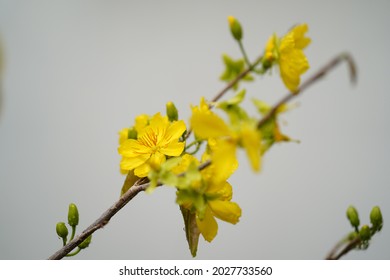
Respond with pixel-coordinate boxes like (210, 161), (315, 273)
(0, 0), (390, 259)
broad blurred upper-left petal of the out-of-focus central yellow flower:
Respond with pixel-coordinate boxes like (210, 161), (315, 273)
(190, 111), (231, 139)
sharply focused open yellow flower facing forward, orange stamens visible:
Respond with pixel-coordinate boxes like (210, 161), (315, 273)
(118, 113), (186, 178)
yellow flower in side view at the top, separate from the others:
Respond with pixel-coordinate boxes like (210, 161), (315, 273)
(265, 24), (311, 92)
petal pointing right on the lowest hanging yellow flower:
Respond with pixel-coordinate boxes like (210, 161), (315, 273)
(208, 200), (241, 224)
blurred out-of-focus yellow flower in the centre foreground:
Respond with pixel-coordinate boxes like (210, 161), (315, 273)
(190, 99), (261, 172)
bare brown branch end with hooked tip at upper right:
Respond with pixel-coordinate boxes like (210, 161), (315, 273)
(257, 53), (357, 128)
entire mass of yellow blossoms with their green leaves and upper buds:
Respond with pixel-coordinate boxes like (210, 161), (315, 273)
(118, 17), (310, 255)
